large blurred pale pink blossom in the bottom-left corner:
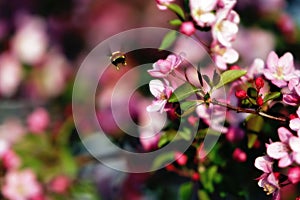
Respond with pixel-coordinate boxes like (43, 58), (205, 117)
(2, 169), (42, 200)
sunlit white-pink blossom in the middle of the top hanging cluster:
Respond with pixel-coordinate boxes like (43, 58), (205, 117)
(212, 9), (240, 47)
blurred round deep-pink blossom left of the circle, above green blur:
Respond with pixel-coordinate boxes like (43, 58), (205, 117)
(27, 108), (50, 133)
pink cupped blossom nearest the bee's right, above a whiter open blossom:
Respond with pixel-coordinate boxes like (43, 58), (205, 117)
(148, 55), (182, 78)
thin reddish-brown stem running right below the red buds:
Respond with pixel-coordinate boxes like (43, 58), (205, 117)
(209, 99), (287, 122)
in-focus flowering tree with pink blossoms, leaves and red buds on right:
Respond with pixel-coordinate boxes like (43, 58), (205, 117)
(142, 0), (300, 200)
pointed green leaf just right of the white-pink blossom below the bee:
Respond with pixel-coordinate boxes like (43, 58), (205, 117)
(169, 83), (199, 103)
